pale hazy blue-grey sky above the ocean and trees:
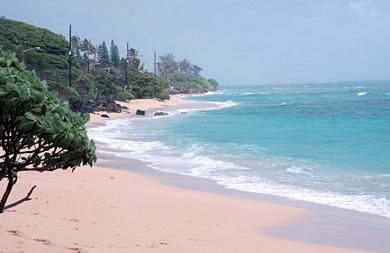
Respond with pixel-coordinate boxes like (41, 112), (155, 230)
(0, 0), (390, 85)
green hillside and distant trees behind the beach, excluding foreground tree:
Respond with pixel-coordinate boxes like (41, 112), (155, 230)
(0, 18), (218, 111)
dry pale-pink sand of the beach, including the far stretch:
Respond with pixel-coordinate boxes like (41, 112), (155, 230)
(0, 98), (382, 253)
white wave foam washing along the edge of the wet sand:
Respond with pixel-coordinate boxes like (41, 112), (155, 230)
(88, 101), (390, 218)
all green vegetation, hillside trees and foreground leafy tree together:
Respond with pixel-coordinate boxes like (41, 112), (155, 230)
(0, 18), (218, 212)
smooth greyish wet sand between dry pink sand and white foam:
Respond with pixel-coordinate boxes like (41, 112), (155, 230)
(90, 97), (390, 252)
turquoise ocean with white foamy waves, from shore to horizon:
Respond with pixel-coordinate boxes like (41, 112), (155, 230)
(89, 81), (390, 218)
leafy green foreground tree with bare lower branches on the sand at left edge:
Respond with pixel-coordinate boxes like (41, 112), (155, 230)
(0, 49), (96, 212)
